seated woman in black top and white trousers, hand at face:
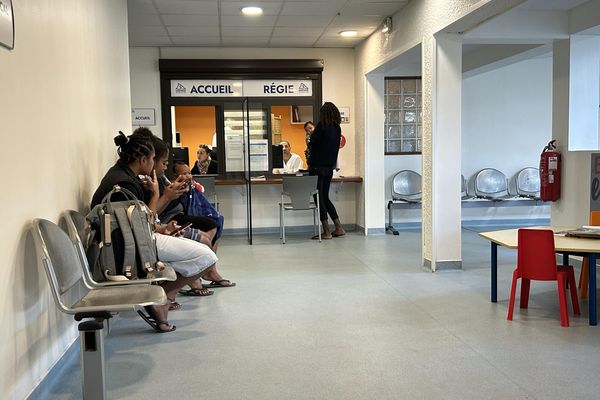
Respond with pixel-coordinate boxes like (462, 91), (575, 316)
(91, 133), (217, 333)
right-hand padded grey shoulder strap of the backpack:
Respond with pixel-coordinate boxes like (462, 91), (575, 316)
(127, 203), (158, 275)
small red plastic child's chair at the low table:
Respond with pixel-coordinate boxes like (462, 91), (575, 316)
(506, 229), (580, 326)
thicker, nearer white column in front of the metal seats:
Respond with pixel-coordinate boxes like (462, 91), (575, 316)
(422, 34), (462, 272)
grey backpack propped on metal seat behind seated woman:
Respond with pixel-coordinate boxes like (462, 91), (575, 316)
(86, 185), (164, 281)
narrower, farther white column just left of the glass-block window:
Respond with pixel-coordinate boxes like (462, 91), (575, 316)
(363, 73), (385, 235)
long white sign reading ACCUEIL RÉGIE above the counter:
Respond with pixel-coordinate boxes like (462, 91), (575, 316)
(171, 79), (312, 97)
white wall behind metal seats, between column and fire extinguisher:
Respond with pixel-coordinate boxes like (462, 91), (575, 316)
(462, 56), (552, 220)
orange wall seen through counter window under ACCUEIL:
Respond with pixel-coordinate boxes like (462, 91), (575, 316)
(175, 106), (217, 166)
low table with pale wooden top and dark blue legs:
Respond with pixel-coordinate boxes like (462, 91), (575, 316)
(479, 226), (600, 325)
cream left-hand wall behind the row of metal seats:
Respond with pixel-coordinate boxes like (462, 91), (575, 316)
(0, 0), (131, 399)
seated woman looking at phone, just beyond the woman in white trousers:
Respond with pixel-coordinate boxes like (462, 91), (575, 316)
(134, 128), (235, 294)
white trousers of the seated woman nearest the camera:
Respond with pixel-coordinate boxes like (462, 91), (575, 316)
(155, 233), (218, 277)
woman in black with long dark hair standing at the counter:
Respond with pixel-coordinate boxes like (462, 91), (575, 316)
(308, 102), (346, 239)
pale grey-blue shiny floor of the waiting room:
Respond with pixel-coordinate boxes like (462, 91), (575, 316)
(35, 230), (600, 400)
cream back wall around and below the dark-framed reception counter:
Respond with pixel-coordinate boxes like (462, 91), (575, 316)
(130, 47), (362, 229)
